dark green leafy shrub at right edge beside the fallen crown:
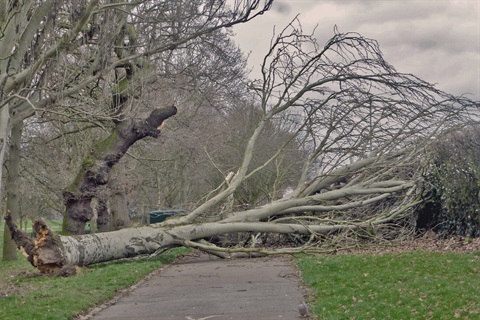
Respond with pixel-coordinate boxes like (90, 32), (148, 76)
(417, 128), (480, 237)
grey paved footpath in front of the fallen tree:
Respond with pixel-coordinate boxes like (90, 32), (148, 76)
(80, 252), (306, 320)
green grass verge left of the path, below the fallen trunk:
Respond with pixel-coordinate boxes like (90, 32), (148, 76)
(0, 248), (188, 320)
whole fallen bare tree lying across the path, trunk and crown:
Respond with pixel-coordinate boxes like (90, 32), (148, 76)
(3, 22), (478, 273)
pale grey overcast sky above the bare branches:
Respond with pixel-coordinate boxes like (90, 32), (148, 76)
(234, 0), (480, 100)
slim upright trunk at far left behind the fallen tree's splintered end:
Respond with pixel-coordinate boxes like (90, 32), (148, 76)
(3, 121), (23, 261)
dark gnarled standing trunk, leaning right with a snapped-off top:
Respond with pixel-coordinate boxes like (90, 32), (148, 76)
(63, 106), (177, 234)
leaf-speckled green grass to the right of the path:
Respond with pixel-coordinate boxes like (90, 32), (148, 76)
(297, 251), (480, 320)
